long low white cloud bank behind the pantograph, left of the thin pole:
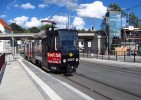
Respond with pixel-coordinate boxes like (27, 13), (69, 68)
(9, 15), (68, 28)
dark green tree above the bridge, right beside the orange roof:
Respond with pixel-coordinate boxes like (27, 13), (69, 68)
(9, 23), (26, 33)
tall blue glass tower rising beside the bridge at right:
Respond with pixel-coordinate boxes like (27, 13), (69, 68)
(107, 11), (122, 50)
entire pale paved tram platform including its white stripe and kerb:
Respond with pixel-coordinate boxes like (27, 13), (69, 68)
(0, 55), (94, 100)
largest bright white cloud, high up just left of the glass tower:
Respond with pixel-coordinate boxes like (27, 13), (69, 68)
(77, 1), (107, 18)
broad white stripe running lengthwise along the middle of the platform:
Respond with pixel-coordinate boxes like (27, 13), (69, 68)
(19, 60), (63, 100)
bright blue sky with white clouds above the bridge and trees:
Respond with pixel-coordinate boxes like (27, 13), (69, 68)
(0, 0), (141, 30)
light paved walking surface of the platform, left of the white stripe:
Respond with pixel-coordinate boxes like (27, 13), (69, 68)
(0, 56), (44, 100)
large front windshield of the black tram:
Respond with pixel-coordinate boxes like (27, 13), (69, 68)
(60, 31), (78, 50)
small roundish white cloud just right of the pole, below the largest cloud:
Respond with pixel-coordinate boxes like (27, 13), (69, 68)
(72, 17), (85, 29)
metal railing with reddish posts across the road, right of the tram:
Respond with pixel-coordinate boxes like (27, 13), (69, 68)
(80, 50), (141, 63)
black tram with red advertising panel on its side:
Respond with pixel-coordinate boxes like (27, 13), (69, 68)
(24, 22), (79, 73)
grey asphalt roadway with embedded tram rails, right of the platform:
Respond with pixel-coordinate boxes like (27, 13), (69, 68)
(51, 61), (141, 100)
